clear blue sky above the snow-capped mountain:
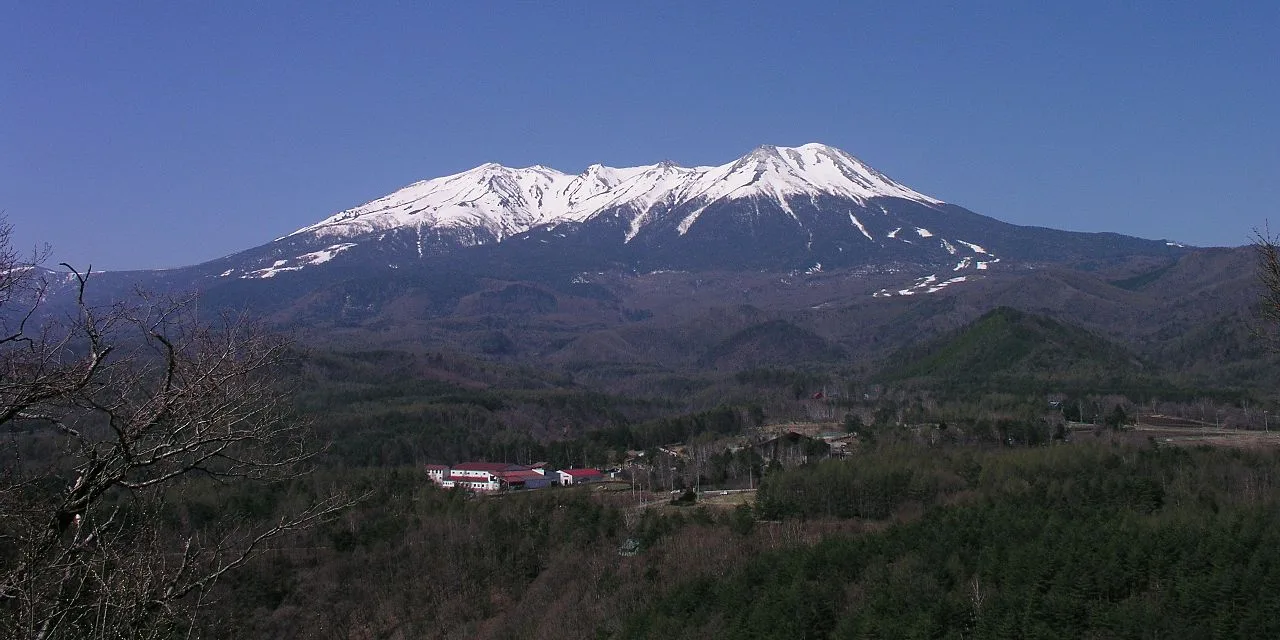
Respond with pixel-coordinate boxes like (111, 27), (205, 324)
(0, 0), (1280, 269)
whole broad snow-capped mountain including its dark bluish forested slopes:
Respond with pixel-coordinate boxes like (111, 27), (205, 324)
(47, 143), (1194, 340)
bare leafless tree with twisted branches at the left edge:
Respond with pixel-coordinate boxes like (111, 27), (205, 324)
(0, 220), (349, 639)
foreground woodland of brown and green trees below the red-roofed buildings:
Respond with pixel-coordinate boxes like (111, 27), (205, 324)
(186, 440), (1280, 637)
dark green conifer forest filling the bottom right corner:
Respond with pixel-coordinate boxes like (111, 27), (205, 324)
(623, 445), (1280, 637)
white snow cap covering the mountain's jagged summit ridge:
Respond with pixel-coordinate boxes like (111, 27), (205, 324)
(285, 143), (942, 242)
